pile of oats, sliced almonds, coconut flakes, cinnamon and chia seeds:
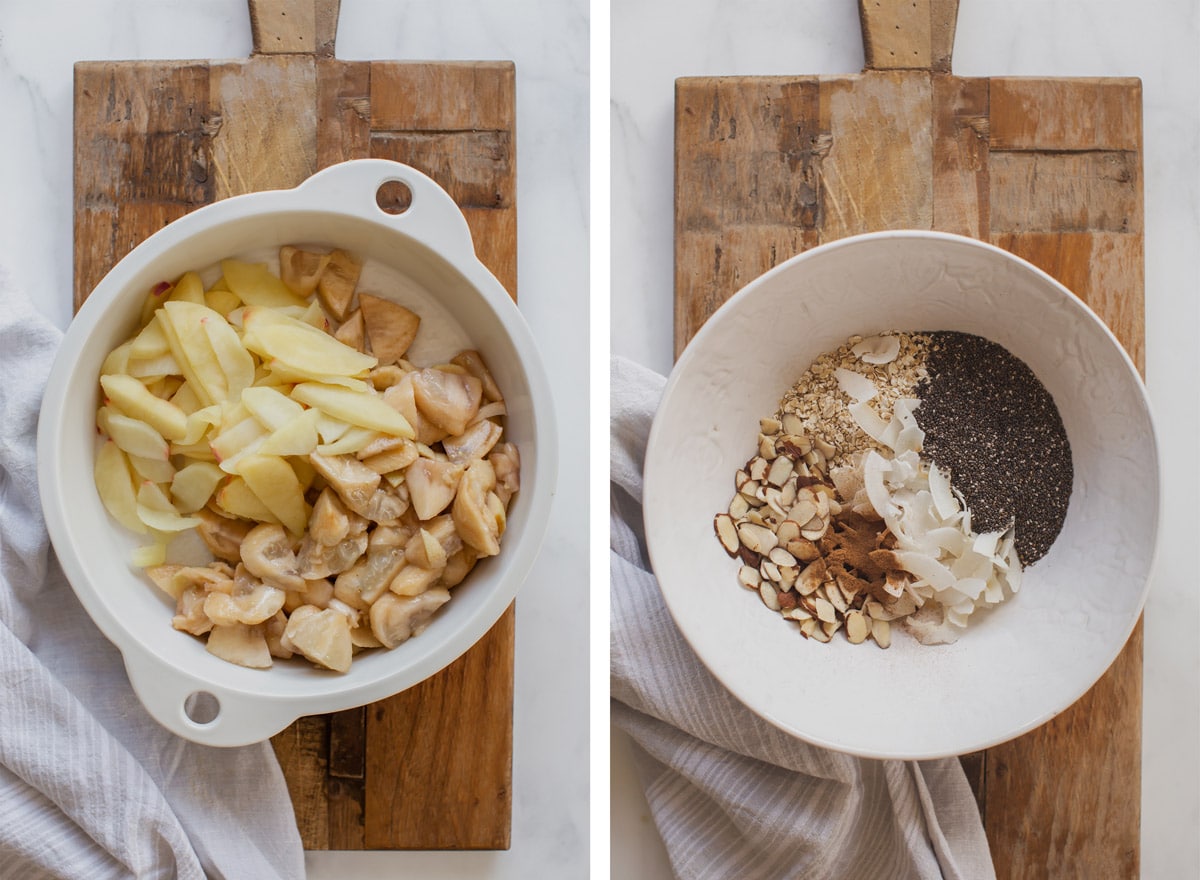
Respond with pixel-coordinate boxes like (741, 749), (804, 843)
(714, 331), (1073, 647)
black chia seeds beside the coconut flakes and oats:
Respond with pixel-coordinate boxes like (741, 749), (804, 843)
(916, 331), (1074, 565)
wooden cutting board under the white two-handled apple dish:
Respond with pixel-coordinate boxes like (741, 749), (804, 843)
(74, 0), (516, 850)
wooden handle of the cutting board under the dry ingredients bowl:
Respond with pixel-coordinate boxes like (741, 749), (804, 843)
(858, 0), (959, 73)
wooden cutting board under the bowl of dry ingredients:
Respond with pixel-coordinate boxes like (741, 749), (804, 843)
(674, 0), (1144, 880)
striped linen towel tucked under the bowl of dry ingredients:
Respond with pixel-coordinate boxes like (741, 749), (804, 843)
(610, 359), (995, 880)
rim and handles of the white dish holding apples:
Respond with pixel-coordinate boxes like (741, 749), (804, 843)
(37, 160), (558, 746)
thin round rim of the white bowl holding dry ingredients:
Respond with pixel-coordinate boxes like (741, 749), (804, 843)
(642, 229), (1164, 760)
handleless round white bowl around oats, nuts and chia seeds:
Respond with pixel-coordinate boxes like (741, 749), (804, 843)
(644, 232), (1159, 759)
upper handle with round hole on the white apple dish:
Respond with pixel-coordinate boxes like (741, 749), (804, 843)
(289, 158), (475, 262)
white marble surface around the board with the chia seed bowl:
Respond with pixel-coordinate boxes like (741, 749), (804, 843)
(611, 0), (1200, 880)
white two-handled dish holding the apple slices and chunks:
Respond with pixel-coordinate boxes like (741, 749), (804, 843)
(37, 160), (557, 746)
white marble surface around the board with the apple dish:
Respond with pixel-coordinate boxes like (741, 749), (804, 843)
(0, 0), (588, 880)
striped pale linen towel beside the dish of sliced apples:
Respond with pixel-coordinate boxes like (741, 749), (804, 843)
(0, 273), (305, 880)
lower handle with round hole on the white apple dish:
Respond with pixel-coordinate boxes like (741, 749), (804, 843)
(125, 652), (298, 746)
